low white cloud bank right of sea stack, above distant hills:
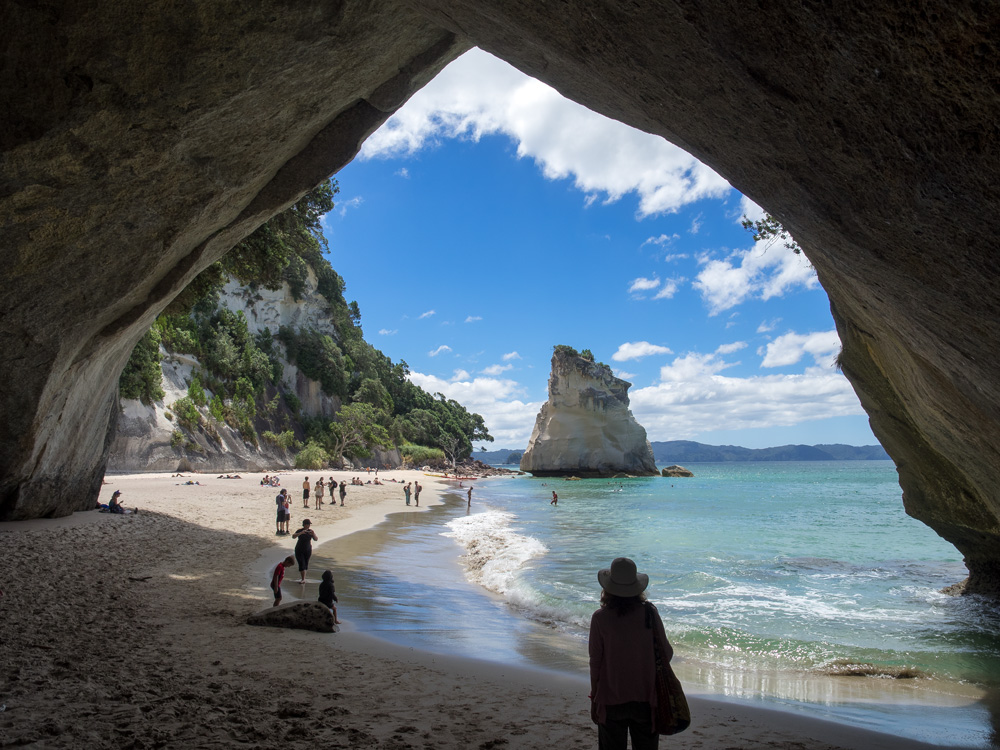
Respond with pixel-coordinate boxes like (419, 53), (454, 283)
(630, 347), (864, 440)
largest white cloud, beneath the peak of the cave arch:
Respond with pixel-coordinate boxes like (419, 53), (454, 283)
(361, 49), (730, 216)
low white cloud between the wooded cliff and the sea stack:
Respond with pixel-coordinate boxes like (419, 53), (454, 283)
(409, 372), (542, 448)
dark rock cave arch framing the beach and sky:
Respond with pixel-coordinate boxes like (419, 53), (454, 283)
(0, 0), (1000, 594)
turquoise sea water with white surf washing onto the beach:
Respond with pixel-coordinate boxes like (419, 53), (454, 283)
(319, 461), (1000, 746)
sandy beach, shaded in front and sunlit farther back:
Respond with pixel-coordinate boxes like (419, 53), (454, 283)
(0, 471), (968, 750)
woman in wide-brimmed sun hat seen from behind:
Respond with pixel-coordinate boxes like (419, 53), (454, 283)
(590, 557), (674, 750)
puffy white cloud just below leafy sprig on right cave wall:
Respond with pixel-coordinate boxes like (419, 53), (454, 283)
(693, 241), (819, 315)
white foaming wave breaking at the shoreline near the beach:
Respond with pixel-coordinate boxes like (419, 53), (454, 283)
(442, 510), (548, 595)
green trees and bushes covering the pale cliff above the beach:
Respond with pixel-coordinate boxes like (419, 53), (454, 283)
(119, 180), (493, 467)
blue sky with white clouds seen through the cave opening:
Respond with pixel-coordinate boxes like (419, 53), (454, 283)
(324, 50), (876, 448)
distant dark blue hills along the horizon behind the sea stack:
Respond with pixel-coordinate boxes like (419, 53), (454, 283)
(472, 440), (889, 465)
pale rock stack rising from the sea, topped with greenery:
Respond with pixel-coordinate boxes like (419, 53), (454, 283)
(521, 351), (657, 477)
